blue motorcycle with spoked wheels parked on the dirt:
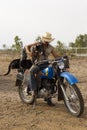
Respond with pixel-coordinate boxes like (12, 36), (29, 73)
(17, 57), (84, 117)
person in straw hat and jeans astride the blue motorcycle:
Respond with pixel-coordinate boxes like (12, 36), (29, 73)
(25, 32), (58, 106)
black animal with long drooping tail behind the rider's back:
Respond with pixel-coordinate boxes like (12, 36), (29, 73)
(4, 59), (32, 75)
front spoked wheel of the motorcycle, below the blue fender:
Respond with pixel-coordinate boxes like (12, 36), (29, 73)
(64, 82), (84, 117)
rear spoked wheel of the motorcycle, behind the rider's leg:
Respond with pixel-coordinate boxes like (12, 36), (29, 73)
(18, 84), (34, 104)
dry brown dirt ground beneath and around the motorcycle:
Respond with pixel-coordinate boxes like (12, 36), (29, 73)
(0, 55), (87, 130)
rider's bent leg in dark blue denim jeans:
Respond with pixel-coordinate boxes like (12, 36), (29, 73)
(29, 65), (40, 91)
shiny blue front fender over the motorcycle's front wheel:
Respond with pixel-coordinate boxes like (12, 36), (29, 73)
(60, 72), (79, 85)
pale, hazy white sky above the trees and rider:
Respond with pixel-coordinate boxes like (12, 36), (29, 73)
(0, 0), (87, 49)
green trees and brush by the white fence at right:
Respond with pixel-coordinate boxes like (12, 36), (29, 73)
(56, 34), (87, 55)
